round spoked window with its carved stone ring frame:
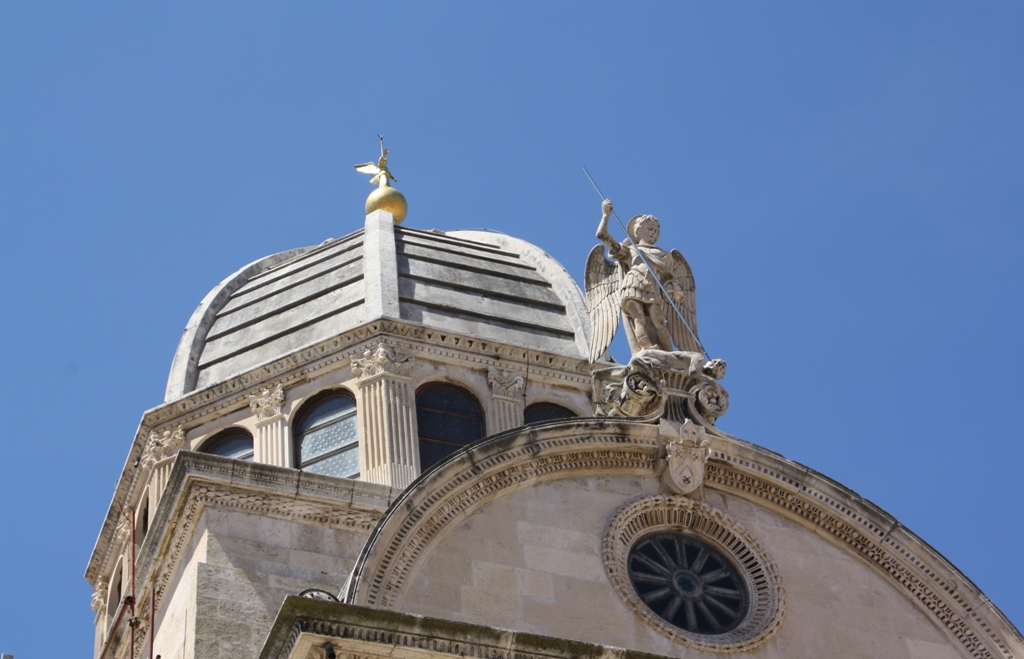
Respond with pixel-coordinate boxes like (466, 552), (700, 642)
(602, 495), (784, 652)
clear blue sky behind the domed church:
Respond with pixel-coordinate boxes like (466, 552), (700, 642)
(0, 2), (1024, 659)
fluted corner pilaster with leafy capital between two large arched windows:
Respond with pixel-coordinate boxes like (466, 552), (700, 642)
(352, 343), (420, 487)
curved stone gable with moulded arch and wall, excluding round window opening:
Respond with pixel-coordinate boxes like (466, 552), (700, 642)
(342, 419), (1024, 659)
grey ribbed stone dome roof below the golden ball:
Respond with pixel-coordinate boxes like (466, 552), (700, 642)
(165, 213), (589, 401)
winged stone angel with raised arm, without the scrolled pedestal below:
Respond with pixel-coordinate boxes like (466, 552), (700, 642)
(585, 200), (702, 363)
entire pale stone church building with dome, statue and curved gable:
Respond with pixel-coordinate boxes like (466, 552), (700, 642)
(85, 203), (1024, 659)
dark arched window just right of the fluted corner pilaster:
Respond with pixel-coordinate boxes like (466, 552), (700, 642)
(416, 385), (483, 469)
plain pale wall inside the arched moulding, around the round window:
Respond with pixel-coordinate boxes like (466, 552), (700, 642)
(395, 477), (961, 659)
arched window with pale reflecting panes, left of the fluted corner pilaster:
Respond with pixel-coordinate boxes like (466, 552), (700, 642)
(295, 391), (359, 478)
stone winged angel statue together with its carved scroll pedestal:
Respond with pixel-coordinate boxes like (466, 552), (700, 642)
(586, 200), (729, 426)
